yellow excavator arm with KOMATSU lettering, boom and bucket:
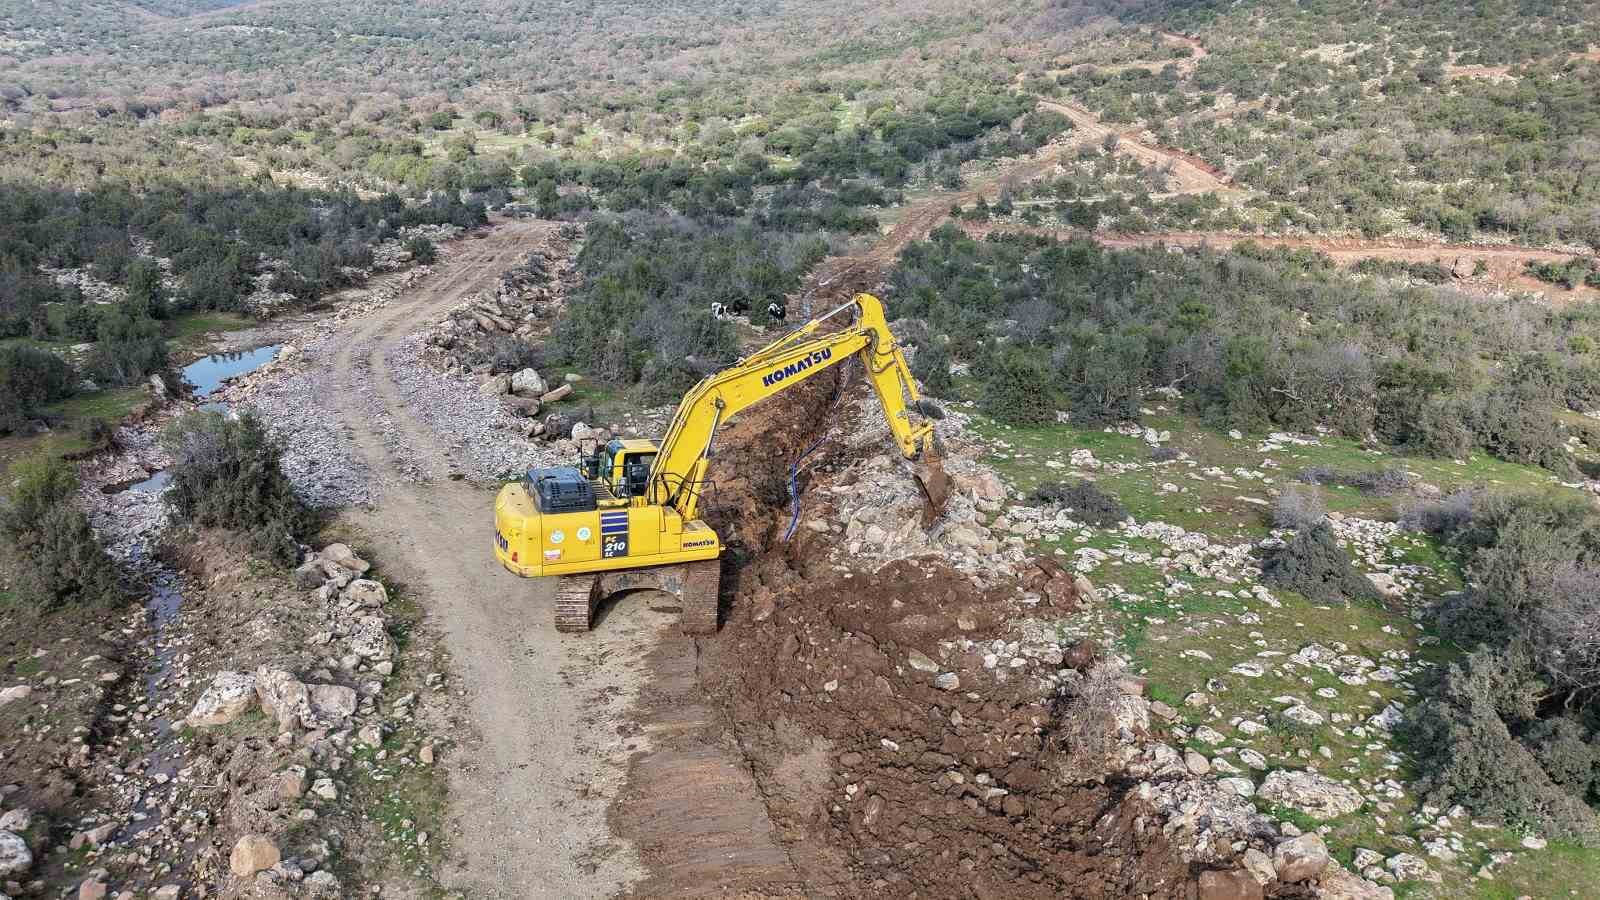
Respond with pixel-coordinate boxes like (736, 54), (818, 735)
(650, 293), (949, 520)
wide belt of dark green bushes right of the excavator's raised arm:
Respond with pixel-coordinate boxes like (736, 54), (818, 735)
(890, 226), (1600, 474)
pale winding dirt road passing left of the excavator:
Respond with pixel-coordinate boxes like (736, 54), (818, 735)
(312, 223), (649, 897)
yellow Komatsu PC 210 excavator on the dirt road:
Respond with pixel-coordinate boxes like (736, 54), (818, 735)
(494, 293), (949, 634)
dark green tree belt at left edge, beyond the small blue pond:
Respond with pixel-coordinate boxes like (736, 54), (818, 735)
(0, 183), (485, 333)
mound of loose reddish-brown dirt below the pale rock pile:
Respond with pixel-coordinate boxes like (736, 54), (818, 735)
(701, 549), (1190, 897)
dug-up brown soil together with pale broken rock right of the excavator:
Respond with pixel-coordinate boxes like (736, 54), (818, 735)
(662, 366), (1389, 898)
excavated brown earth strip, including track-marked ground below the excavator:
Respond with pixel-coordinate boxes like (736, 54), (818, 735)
(611, 353), (1195, 898)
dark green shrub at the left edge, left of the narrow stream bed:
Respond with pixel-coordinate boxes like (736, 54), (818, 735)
(0, 460), (126, 612)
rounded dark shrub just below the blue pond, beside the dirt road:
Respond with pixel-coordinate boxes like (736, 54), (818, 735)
(162, 412), (310, 565)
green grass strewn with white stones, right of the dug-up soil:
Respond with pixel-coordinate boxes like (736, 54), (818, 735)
(957, 405), (1600, 897)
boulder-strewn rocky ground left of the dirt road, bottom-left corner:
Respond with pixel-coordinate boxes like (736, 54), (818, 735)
(0, 525), (446, 900)
